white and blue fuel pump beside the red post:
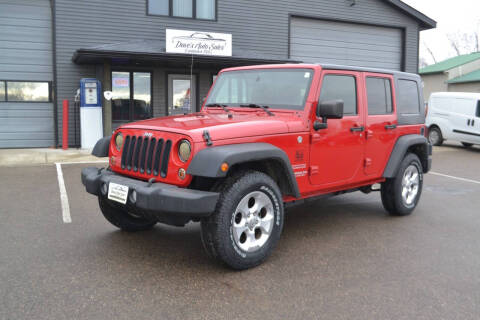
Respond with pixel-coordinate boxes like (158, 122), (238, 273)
(80, 78), (103, 149)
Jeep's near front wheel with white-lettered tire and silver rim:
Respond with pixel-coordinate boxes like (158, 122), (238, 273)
(201, 171), (284, 270)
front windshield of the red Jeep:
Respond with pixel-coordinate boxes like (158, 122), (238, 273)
(206, 69), (313, 110)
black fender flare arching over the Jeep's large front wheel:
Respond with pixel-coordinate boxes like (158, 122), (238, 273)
(187, 143), (300, 198)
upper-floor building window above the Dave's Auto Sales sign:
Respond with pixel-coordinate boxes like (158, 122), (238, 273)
(147, 0), (216, 20)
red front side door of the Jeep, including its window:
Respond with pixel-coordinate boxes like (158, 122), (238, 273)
(310, 71), (365, 189)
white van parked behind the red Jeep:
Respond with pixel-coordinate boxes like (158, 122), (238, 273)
(425, 92), (480, 147)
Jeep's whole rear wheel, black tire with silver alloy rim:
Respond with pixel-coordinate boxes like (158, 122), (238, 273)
(380, 153), (423, 216)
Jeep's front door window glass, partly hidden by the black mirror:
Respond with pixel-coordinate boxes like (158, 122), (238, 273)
(319, 74), (357, 116)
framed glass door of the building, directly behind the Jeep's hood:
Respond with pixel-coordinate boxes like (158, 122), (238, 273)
(168, 74), (197, 115)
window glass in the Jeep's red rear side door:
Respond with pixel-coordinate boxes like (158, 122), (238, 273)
(366, 77), (393, 115)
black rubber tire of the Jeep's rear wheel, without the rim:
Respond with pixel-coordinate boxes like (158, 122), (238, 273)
(380, 153), (423, 216)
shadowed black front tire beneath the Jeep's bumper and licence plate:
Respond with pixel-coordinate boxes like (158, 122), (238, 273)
(98, 197), (157, 232)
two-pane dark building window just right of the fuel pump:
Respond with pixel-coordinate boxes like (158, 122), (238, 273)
(112, 71), (152, 128)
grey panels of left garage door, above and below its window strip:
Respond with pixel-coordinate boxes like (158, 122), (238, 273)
(0, 0), (55, 148)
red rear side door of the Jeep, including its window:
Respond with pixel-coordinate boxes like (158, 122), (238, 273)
(363, 73), (397, 178)
